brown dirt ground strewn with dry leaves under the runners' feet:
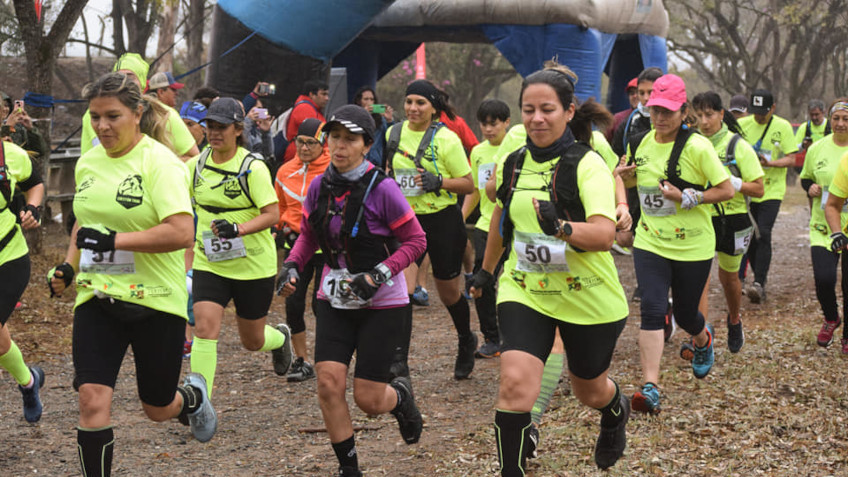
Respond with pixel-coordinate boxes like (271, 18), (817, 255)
(0, 187), (848, 476)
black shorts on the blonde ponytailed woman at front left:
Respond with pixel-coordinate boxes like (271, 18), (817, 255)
(73, 298), (186, 407)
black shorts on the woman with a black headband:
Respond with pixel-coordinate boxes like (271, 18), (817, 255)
(416, 206), (468, 280)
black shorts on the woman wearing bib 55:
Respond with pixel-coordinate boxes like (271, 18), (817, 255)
(191, 270), (276, 320)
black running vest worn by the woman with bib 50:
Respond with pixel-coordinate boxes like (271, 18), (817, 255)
(497, 142), (592, 253)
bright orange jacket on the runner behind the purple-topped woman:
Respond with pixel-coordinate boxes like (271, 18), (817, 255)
(274, 147), (330, 233)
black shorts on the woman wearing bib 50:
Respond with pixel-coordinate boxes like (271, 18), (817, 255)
(498, 301), (627, 379)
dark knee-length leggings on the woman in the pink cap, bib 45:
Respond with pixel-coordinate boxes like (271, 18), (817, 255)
(633, 248), (713, 336)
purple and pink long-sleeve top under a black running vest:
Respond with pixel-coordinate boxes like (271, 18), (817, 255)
(286, 166), (427, 308)
